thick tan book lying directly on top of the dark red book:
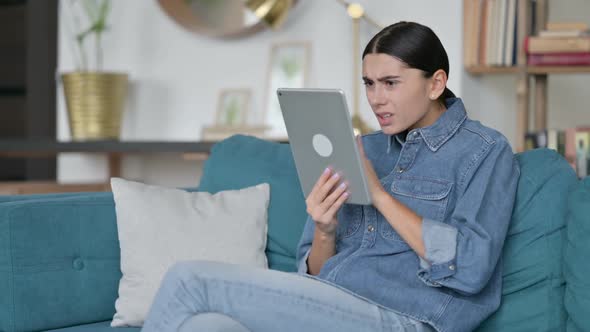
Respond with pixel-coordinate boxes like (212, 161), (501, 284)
(525, 37), (590, 54)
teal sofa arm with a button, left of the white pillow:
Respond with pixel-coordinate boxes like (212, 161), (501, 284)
(0, 193), (121, 332)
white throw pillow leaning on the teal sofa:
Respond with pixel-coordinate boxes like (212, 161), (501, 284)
(111, 178), (270, 326)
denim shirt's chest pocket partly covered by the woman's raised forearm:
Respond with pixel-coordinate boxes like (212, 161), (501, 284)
(380, 177), (453, 241)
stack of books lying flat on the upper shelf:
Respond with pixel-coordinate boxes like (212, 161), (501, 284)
(525, 22), (590, 66)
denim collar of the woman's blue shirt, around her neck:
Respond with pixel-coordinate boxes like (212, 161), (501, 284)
(387, 98), (467, 152)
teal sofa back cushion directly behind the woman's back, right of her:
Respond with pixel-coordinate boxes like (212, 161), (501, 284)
(479, 149), (578, 331)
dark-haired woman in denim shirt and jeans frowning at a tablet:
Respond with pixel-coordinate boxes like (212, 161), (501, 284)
(144, 22), (519, 332)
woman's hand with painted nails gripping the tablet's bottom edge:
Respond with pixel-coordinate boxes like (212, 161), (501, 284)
(305, 168), (350, 236)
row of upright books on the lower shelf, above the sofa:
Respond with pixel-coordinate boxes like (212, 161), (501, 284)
(525, 127), (590, 178)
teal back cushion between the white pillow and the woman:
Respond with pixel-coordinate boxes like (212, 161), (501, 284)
(199, 135), (307, 271)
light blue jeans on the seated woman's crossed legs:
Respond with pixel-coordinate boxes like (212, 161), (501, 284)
(142, 261), (433, 332)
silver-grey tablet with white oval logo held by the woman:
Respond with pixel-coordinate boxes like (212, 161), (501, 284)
(277, 88), (371, 205)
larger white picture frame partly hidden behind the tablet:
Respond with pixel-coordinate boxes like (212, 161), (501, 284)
(264, 42), (311, 139)
